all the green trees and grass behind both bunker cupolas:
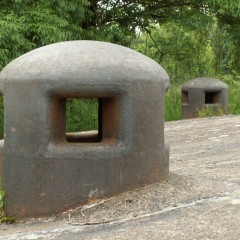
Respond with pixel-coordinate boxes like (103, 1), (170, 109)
(0, 0), (240, 135)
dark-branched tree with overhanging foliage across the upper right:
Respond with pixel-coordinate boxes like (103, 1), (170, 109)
(84, 0), (240, 71)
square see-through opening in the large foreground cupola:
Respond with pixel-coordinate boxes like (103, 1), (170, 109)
(65, 98), (116, 142)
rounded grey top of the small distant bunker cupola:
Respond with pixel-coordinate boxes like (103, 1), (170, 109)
(182, 77), (228, 89)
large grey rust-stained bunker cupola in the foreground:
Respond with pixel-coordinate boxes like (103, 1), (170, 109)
(0, 41), (172, 218)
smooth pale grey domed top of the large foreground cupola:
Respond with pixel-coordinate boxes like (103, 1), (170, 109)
(0, 40), (169, 88)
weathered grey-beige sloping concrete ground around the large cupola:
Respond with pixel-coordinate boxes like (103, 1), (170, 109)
(0, 116), (240, 240)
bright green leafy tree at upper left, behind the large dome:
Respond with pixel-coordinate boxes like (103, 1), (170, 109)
(0, 0), (88, 69)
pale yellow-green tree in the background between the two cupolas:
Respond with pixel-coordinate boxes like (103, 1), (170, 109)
(132, 21), (214, 83)
